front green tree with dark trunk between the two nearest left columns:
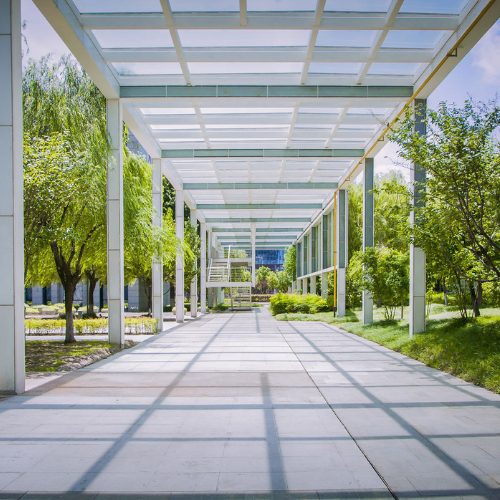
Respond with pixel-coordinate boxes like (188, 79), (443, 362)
(24, 133), (106, 343)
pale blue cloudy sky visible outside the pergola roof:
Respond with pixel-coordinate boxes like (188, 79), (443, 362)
(22, 0), (500, 177)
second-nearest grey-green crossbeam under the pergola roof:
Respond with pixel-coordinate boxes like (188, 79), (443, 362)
(161, 149), (364, 158)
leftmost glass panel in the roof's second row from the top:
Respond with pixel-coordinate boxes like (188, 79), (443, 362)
(92, 30), (173, 49)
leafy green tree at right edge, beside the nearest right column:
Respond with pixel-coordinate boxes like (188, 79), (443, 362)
(391, 99), (500, 302)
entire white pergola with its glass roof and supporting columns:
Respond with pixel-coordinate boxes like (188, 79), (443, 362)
(0, 0), (500, 392)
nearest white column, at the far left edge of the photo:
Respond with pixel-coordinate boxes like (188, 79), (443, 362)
(0, 0), (25, 393)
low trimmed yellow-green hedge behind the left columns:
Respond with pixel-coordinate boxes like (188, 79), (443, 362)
(24, 318), (157, 335)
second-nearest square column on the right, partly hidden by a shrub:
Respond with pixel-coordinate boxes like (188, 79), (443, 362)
(362, 158), (375, 325)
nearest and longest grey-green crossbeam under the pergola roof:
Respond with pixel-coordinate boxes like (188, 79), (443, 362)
(120, 85), (413, 99)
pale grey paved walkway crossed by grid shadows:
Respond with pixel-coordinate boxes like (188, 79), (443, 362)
(0, 309), (500, 498)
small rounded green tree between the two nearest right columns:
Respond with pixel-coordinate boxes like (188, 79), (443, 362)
(362, 246), (409, 320)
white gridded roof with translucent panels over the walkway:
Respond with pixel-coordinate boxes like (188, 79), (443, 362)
(34, 0), (499, 248)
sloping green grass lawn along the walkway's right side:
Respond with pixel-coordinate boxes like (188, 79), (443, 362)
(276, 305), (500, 393)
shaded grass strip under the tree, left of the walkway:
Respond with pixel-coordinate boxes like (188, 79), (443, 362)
(26, 340), (130, 372)
